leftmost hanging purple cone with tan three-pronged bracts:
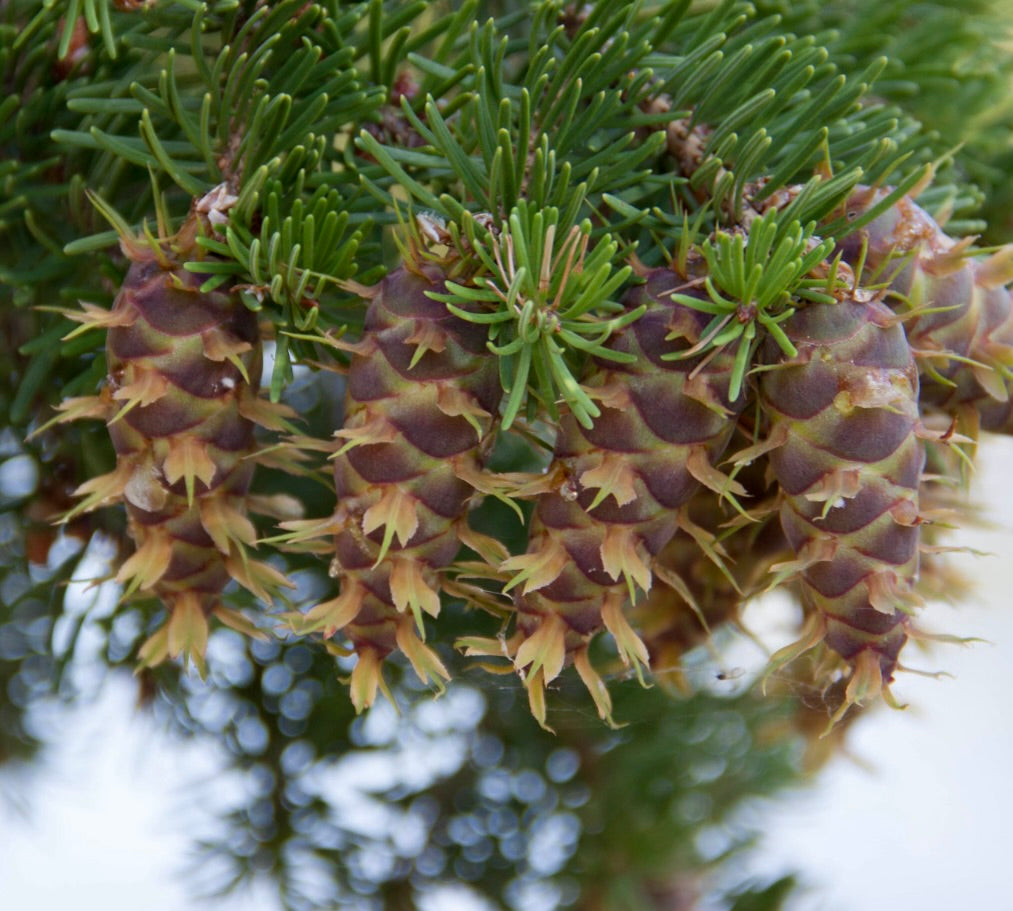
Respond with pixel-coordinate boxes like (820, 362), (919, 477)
(52, 211), (287, 667)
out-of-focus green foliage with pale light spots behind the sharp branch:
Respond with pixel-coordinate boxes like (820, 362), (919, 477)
(0, 0), (1013, 911)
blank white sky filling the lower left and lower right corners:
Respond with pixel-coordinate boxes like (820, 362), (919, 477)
(0, 439), (1013, 911)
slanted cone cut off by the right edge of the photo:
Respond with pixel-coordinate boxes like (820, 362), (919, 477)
(844, 188), (1013, 433)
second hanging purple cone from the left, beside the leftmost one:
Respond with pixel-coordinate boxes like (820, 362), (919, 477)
(285, 256), (501, 710)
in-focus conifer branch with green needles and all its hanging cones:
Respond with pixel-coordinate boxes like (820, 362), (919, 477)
(0, 0), (1013, 741)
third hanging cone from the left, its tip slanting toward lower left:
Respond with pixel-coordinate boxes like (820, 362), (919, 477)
(503, 270), (745, 723)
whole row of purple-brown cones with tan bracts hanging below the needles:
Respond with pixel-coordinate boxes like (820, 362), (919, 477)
(59, 189), (1013, 724)
